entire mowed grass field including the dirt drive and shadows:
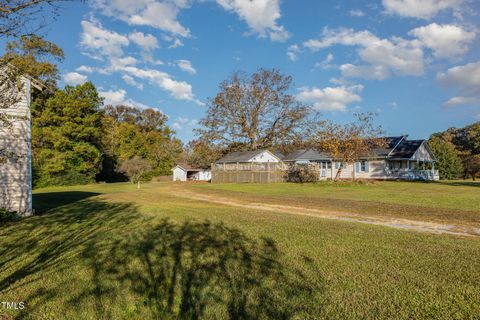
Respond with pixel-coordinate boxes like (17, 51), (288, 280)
(0, 182), (480, 319)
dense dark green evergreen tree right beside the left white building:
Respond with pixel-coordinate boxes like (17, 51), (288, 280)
(32, 82), (103, 186)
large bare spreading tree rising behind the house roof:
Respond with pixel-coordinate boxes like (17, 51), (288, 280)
(196, 69), (314, 150)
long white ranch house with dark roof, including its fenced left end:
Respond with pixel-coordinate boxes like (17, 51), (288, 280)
(206, 136), (439, 182)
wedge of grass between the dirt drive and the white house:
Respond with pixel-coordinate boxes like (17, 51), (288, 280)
(191, 181), (480, 228)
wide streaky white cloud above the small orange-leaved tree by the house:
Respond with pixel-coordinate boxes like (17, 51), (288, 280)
(304, 28), (424, 79)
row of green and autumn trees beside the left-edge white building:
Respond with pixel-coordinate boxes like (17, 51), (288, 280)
(2, 36), (182, 187)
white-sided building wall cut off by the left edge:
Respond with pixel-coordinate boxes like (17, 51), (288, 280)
(0, 79), (32, 215)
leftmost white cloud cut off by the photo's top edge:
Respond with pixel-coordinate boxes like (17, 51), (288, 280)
(93, 0), (190, 37)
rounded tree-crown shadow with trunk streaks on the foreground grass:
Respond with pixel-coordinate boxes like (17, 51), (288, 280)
(77, 220), (320, 319)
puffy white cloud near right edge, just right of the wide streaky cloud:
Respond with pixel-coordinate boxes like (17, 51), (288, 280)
(409, 23), (475, 58)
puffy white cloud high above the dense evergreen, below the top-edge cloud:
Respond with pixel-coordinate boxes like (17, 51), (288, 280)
(80, 20), (130, 59)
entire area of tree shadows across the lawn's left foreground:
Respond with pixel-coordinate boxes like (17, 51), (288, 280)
(0, 195), (321, 319)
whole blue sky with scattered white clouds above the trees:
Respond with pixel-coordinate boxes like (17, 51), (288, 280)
(6, 0), (480, 142)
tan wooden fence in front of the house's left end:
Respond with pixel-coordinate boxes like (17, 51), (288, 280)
(212, 162), (288, 183)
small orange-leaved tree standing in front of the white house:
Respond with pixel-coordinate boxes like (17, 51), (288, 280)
(315, 113), (386, 180)
